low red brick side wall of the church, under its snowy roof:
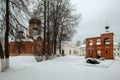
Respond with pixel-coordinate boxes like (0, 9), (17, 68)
(9, 41), (34, 56)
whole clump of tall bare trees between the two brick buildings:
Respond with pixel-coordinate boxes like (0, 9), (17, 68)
(33, 0), (80, 55)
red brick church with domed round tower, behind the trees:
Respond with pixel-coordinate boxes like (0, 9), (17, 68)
(9, 18), (42, 55)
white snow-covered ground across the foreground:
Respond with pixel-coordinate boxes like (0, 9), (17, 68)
(0, 56), (120, 80)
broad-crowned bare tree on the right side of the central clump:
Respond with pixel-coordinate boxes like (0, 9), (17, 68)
(50, 0), (80, 54)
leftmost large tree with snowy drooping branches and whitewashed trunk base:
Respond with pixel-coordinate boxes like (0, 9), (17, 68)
(0, 0), (32, 71)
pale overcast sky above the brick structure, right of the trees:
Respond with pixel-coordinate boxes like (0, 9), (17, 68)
(71, 0), (120, 42)
